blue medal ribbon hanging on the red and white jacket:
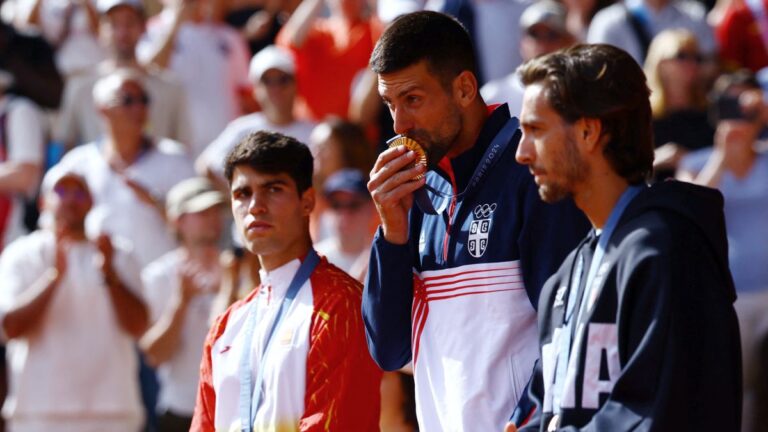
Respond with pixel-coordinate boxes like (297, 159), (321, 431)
(234, 248), (320, 432)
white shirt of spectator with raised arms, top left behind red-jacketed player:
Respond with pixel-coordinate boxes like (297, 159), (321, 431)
(136, 10), (251, 157)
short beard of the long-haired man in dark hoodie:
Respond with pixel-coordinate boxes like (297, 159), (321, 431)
(539, 135), (590, 204)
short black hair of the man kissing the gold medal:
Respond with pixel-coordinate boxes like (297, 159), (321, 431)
(370, 11), (477, 86)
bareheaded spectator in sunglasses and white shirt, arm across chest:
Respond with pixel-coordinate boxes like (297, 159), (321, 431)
(51, 70), (194, 268)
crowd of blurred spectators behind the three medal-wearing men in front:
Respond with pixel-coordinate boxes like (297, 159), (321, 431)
(0, 0), (768, 431)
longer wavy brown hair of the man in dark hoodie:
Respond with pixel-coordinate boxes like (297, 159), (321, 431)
(517, 44), (653, 184)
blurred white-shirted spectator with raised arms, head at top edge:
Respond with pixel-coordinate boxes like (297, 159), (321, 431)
(138, 0), (250, 158)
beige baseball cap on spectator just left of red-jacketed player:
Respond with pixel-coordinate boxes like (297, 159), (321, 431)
(165, 177), (227, 219)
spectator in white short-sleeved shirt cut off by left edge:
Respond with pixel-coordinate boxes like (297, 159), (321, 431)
(0, 73), (45, 251)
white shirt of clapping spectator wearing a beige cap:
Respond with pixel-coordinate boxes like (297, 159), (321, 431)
(141, 249), (216, 417)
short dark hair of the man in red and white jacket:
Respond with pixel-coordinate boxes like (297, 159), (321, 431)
(224, 131), (313, 194)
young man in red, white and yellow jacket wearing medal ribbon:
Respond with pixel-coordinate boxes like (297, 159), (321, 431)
(191, 132), (381, 432)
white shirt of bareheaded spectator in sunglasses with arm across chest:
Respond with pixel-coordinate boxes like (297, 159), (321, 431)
(53, 140), (195, 268)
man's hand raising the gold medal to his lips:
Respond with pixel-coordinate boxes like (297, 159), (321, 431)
(368, 146), (427, 244)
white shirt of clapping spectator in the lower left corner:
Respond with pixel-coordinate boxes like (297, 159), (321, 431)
(0, 230), (143, 420)
